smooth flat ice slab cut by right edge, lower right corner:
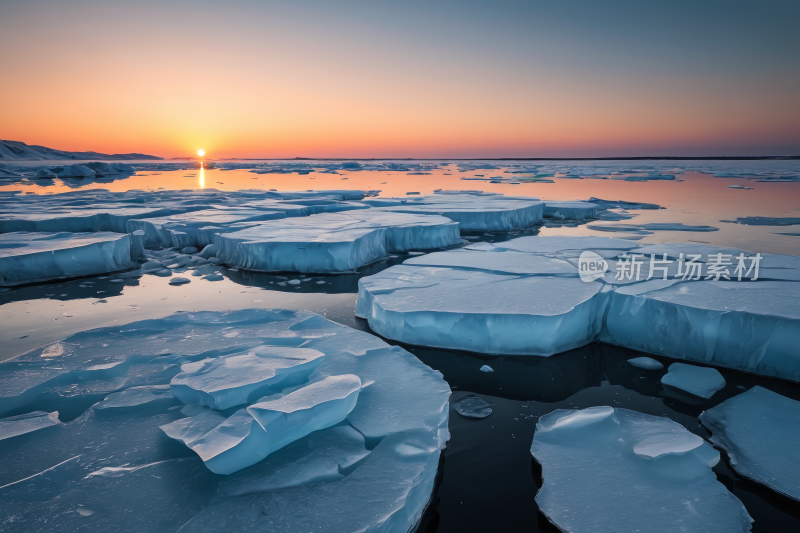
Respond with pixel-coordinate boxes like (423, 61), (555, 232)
(700, 386), (800, 500)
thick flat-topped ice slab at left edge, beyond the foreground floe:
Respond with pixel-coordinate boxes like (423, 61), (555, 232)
(0, 232), (144, 286)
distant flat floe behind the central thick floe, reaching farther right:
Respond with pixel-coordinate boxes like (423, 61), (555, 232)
(365, 194), (544, 231)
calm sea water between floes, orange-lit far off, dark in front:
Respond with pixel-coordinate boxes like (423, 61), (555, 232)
(0, 161), (800, 532)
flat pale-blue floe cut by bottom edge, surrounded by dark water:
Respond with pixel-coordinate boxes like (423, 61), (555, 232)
(531, 407), (752, 533)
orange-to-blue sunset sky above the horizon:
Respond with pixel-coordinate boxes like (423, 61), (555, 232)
(0, 0), (800, 159)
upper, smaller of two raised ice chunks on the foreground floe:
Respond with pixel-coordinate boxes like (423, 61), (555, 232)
(170, 346), (325, 409)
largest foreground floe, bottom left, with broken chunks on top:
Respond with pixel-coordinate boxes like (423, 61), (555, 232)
(0, 310), (450, 532)
